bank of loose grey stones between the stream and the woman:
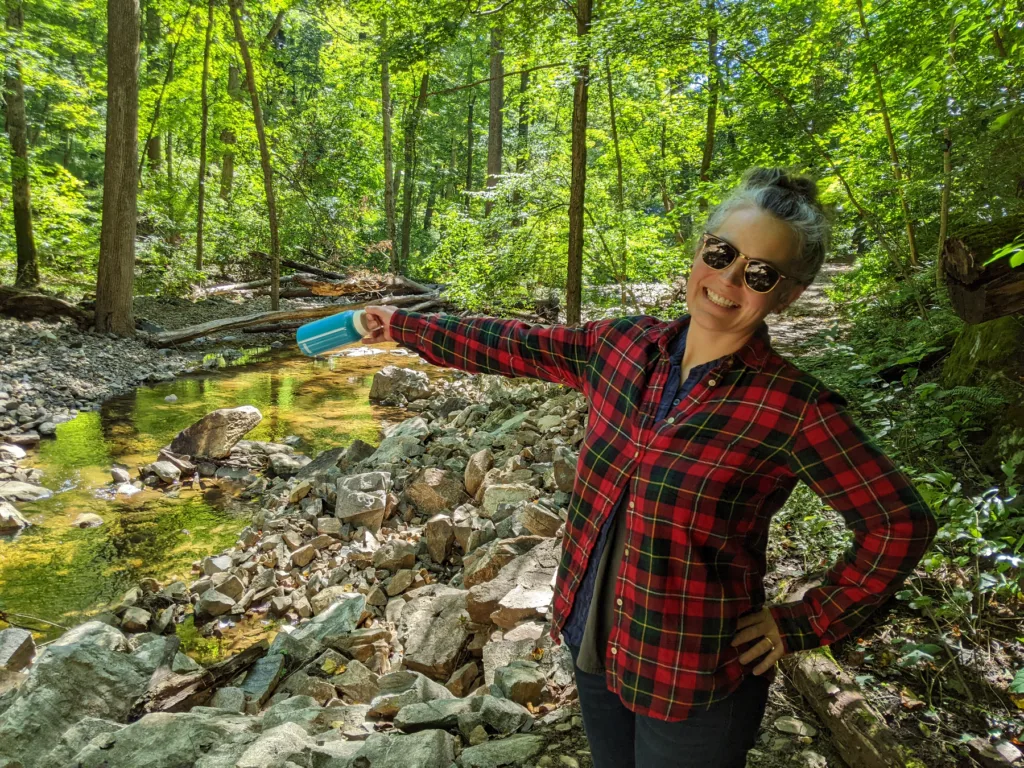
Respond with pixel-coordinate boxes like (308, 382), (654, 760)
(0, 367), (585, 768)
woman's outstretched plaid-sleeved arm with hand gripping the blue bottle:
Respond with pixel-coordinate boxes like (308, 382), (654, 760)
(367, 306), (611, 390)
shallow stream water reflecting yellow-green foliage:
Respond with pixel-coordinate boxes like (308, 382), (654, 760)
(0, 345), (441, 638)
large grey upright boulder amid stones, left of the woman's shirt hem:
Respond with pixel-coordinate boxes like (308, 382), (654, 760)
(398, 586), (469, 682)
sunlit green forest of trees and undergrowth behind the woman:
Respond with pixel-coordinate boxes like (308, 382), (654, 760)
(0, 0), (1024, 768)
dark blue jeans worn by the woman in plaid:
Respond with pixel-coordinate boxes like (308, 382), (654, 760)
(568, 645), (771, 768)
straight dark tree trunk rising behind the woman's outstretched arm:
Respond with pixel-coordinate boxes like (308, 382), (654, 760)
(565, 0), (592, 326)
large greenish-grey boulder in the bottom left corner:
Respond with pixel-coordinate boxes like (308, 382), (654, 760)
(0, 633), (152, 768)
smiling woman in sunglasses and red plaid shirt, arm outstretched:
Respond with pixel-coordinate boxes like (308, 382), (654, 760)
(368, 169), (935, 768)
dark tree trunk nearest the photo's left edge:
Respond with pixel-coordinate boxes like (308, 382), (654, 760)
(5, 0), (39, 289)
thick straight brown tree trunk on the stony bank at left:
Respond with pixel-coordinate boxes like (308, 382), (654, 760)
(96, 0), (139, 336)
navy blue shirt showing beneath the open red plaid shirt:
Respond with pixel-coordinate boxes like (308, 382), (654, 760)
(562, 324), (721, 646)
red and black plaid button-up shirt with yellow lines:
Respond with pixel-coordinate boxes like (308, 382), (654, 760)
(391, 310), (936, 720)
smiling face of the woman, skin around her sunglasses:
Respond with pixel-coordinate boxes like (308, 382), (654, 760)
(686, 206), (804, 336)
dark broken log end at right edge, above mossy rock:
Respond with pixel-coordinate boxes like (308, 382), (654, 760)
(939, 214), (1024, 325)
